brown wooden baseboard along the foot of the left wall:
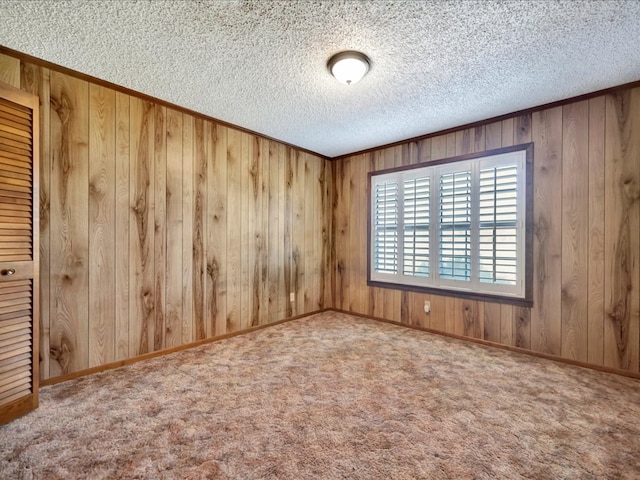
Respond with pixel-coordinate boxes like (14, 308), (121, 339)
(40, 308), (330, 387)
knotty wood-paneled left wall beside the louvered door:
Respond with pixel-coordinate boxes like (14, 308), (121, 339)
(0, 54), (334, 379)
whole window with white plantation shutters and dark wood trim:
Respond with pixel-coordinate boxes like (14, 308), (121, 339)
(368, 144), (533, 305)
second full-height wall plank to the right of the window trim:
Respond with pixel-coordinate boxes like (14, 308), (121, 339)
(561, 101), (589, 362)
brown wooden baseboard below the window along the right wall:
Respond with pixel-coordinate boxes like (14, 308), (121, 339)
(327, 308), (640, 380)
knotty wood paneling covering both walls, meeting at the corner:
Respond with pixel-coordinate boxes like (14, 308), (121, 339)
(0, 47), (640, 378)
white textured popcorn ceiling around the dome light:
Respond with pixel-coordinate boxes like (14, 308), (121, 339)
(0, 0), (640, 157)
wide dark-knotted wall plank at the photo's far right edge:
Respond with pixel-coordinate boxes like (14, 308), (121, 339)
(604, 89), (640, 371)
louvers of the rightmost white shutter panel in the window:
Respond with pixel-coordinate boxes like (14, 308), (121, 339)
(479, 165), (518, 285)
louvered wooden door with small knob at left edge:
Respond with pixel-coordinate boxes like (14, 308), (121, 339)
(0, 83), (40, 424)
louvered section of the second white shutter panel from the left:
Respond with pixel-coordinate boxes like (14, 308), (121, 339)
(402, 177), (430, 277)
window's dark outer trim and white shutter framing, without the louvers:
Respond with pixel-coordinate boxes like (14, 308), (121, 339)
(367, 142), (533, 307)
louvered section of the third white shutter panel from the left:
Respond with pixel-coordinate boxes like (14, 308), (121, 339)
(439, 170), (471, 281)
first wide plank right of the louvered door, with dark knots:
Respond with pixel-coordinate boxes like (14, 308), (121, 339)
(49, 72), (89, 376)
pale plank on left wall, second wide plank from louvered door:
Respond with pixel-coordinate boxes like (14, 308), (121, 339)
(88, 85), (116, 367)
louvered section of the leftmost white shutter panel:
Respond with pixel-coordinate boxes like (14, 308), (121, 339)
(373, 181), (399, 273)
